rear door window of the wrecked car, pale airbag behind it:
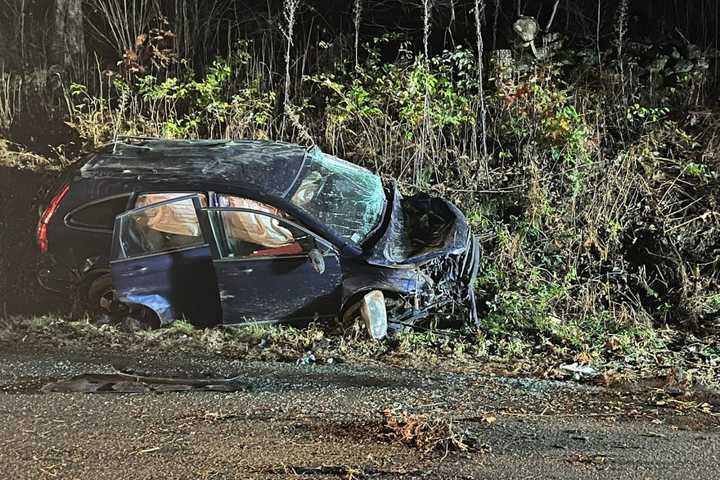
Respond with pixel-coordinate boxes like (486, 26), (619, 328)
(120, 198), (206, 258)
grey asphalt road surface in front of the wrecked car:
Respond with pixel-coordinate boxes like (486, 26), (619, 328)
(0, 345), (720, 479)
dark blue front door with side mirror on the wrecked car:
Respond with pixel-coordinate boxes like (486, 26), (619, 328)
(203, 204), (342, 324)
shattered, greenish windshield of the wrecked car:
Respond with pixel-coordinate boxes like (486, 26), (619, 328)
(290, 148), (385, 243)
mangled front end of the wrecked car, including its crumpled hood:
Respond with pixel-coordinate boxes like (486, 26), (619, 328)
(358, 186), (480, 331)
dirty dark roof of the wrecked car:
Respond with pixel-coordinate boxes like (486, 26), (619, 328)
(80, 140), (306, 197)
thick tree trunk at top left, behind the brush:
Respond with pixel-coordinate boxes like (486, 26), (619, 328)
(51, 0), (85, 67)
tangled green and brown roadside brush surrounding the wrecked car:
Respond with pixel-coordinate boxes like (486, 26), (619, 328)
(0, 0), (720, 379)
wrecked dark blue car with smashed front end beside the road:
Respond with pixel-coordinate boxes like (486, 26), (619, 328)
(37, 139), (479, 338)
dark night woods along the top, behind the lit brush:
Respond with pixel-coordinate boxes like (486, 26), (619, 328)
(0, 0), (720, 70)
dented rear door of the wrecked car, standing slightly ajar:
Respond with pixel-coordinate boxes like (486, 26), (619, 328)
(110, 195), (220, 325)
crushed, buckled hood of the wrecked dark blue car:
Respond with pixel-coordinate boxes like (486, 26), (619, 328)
(367, 185), (469, 267)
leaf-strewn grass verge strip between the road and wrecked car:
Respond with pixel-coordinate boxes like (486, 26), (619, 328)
(0, 316), (720, 385)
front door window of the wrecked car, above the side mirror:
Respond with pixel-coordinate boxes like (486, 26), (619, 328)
(210, 207), (329, 258)
